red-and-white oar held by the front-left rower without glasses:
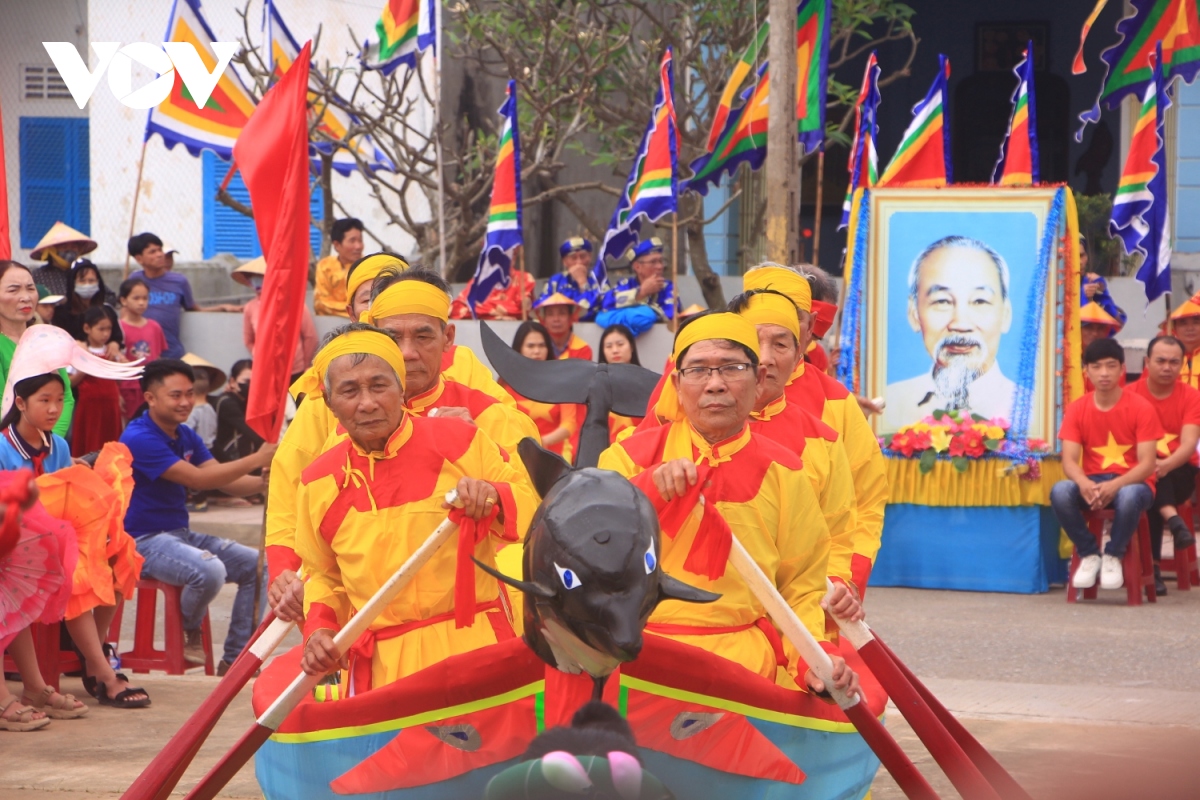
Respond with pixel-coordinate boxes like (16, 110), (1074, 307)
(186, 491), (458, 800)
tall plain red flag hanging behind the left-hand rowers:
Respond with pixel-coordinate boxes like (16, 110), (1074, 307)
(233, 41), (312, 441)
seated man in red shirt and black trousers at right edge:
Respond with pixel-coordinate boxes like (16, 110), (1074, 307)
(1129, 336), (1200, 595)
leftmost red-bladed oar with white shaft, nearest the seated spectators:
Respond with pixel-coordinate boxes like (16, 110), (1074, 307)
(121, 612), (294, 800)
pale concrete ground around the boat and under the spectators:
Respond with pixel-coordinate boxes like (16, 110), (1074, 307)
(0, 507), (1200, 800)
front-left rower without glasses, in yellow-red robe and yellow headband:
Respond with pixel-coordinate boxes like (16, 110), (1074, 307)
(295, 323), (538, 692)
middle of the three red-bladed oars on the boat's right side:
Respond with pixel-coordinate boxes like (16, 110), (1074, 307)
(826, 579), (1014, 800)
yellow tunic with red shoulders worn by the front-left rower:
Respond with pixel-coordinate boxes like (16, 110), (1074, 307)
(296, 415), (538, 691)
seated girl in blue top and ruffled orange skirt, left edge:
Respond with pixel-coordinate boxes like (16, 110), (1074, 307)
(0, 376), (150, 718)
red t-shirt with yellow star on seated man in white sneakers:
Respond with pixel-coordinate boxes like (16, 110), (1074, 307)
(1058, 391), (1163, 487)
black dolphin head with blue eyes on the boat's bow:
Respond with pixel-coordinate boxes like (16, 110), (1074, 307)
(481, 439), (720, 678)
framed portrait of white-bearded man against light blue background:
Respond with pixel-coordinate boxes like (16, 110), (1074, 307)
(860, 187), (1063, 443)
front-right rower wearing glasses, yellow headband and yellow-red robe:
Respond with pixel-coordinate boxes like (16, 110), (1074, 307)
(599, 313), (858, 692)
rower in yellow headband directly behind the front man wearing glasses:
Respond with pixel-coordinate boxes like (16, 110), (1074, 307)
(730, 289), (862, 619)
